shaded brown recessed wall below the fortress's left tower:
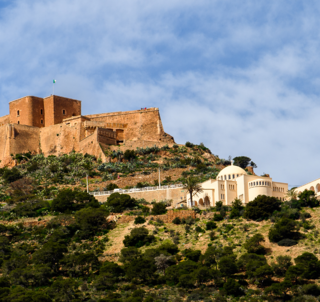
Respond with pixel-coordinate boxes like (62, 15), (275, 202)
(8, 124), (40, 154)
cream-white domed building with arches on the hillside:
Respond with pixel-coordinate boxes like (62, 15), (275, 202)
(187, 165), (288, 208)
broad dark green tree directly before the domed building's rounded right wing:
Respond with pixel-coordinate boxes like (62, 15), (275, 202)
(243, 195), (281, 220)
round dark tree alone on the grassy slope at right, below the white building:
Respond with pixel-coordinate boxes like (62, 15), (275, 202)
(268, 217), (299, 242)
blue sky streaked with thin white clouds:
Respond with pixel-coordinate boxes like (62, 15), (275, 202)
(0, 0), (320, 187)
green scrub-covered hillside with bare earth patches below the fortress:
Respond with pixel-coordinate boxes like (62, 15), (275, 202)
(0, 143), (320, 302)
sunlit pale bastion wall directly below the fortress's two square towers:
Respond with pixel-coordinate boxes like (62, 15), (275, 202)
(40, 124), (80, 156)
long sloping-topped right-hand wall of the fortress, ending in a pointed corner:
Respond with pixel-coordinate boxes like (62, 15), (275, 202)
(87, 108), (174, 142)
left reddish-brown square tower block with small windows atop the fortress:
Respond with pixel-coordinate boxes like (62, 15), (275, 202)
(9, 96), (43, 127)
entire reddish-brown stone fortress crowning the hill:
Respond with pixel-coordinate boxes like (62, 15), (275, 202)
(0, 95), (174, 167)
